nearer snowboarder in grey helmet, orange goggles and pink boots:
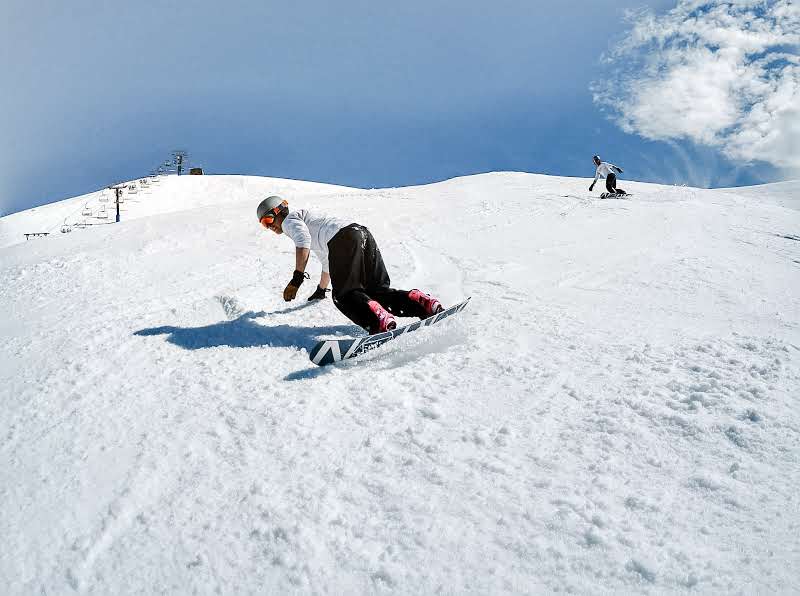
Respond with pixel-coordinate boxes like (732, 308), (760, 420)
(256, 196), (444, 334)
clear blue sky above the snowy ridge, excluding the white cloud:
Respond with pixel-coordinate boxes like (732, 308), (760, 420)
(0, 0), (782, 214)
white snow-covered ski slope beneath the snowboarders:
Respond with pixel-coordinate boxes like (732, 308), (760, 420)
(0, 173), (800, 595)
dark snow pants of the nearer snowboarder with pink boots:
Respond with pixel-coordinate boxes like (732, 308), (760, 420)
(328, 224), (425, 332)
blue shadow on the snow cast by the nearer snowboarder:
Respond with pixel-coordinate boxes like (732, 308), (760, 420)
(134, 311), (363, 350)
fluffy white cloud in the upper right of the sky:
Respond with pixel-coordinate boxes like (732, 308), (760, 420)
(592, 0), (800, 176)
